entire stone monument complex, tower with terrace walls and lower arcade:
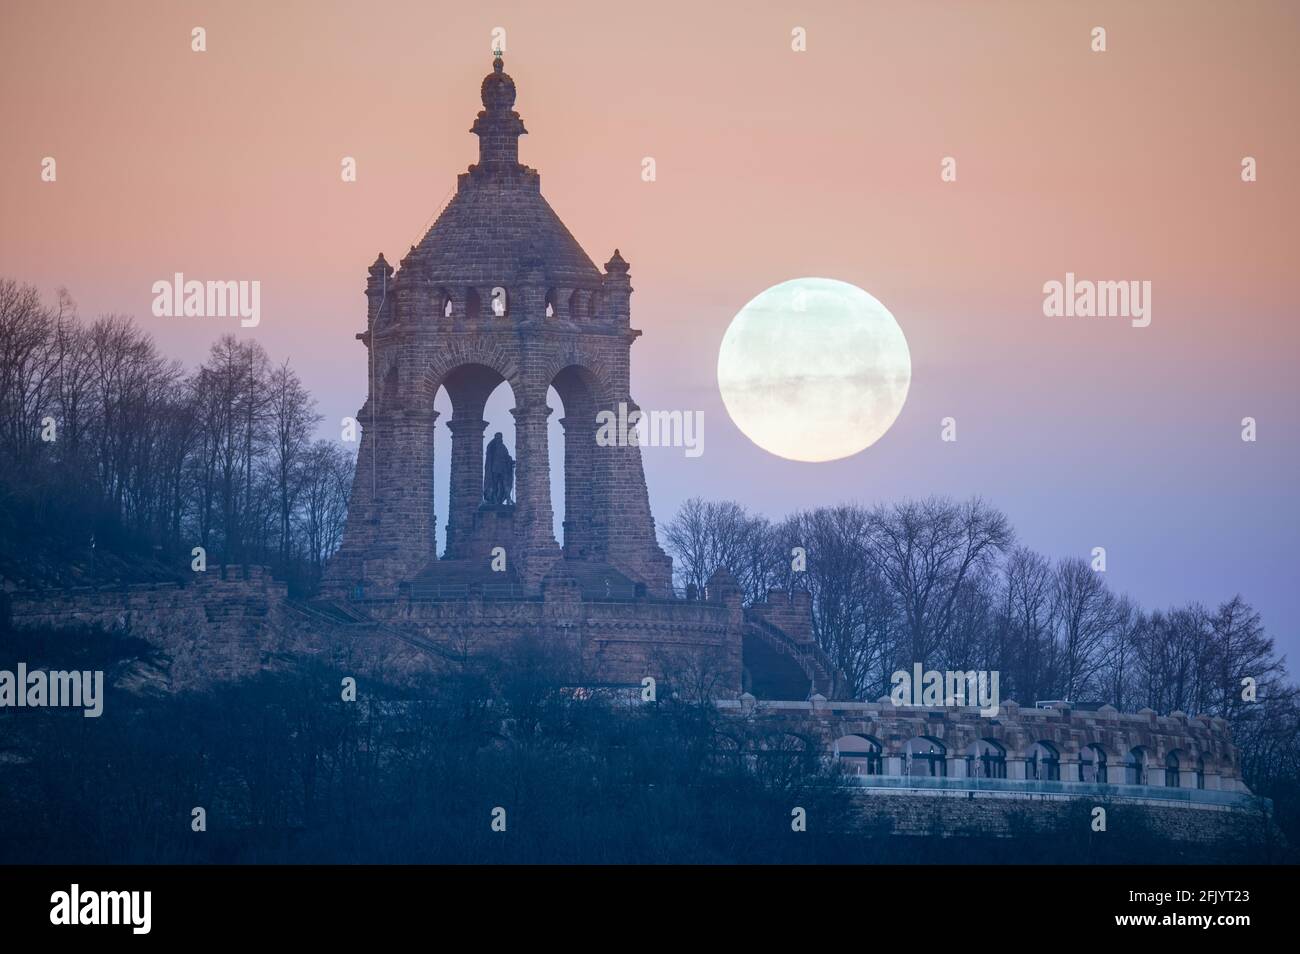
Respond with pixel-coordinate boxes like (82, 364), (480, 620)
(0, 57), (1253, 831)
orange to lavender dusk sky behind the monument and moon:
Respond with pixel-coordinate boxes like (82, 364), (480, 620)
(0, 0), (1300, 649)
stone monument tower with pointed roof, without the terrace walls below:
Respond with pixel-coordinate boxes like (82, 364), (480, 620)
(326, 55), (671, 597)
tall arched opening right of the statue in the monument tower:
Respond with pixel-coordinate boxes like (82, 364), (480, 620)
(547, 365), (605, 560)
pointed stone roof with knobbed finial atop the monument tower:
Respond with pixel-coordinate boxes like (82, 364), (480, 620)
(402, 56), (601, 289)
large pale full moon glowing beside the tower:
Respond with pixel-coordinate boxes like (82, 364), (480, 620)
(718, 278), (911, 461)
